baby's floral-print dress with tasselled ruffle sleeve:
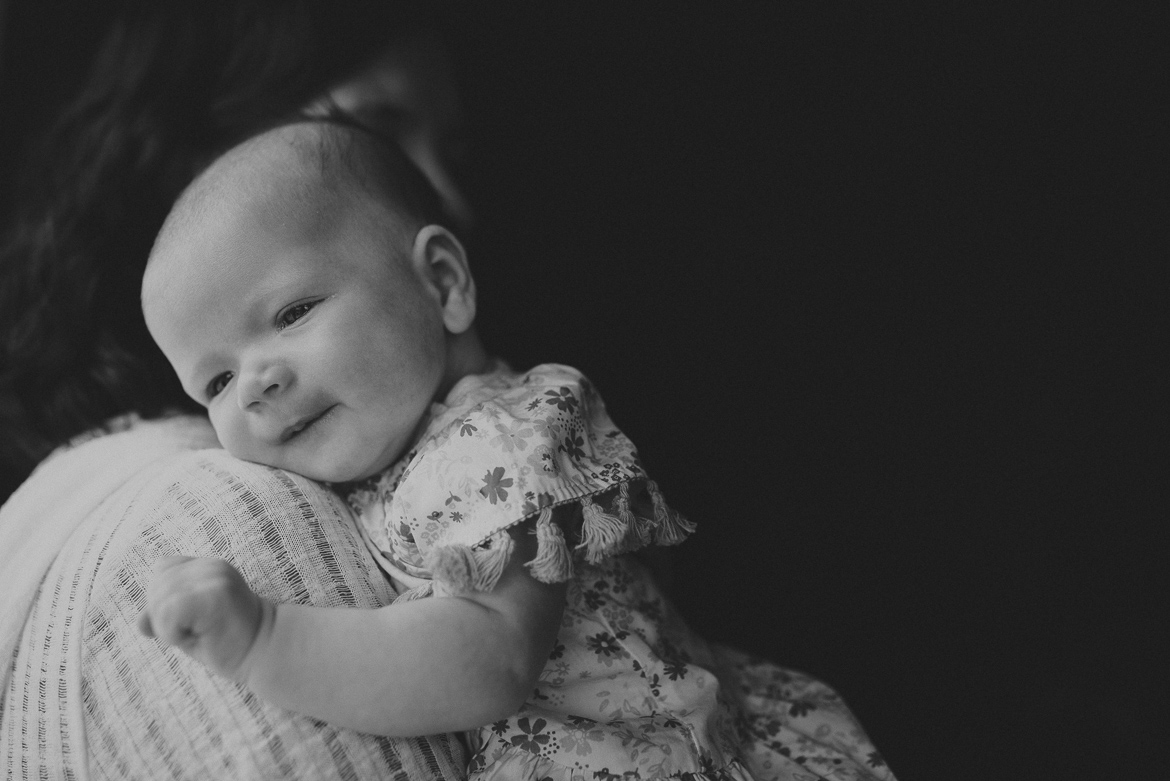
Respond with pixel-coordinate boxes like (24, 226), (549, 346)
(344, 364), (894, 781)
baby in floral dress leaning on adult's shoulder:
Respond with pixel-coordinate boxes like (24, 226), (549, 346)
(140, 120), (892, 781)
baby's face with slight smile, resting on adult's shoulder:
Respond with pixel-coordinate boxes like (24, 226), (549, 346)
(143, 181), (446, 482)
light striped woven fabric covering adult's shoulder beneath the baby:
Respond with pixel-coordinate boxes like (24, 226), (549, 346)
(0, 419), (464, 781)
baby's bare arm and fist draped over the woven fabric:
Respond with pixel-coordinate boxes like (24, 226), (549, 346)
(140, 526), (565, 735)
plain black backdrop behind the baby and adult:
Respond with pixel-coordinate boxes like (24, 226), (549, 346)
(0, 2), (1170, 781)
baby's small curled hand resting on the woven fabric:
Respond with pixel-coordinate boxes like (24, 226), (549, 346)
(138, 555), (275, 680)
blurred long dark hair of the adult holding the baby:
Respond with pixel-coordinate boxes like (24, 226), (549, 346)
(0, 0), (435, 498)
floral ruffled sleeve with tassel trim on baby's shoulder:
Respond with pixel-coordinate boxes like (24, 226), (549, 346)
(358, 364), (694, 597)
